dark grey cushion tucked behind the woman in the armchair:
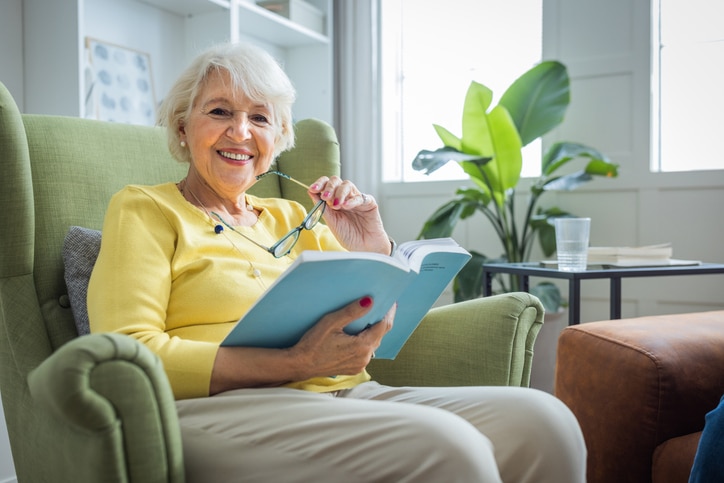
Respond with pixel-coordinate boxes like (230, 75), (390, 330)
(63, 226), (101, 335)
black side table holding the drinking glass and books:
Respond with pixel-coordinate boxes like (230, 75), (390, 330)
(483, 262), (724, 325)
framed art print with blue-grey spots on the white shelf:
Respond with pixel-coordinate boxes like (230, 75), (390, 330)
(85, 37), (156, 126)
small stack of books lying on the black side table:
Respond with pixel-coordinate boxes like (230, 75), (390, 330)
(588, 243), (701, 267)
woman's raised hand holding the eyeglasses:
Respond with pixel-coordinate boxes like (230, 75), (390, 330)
(309, 176), (391, 255)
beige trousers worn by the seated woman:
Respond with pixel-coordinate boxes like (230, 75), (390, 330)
(177, 382), (586, 483)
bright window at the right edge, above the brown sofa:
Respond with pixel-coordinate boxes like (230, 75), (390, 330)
(651, 0), (724, 172)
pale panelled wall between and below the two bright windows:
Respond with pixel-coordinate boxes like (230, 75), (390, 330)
(380, 0), (724, 321)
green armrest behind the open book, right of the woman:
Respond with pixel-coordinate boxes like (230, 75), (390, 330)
(368, 292), (544, 386)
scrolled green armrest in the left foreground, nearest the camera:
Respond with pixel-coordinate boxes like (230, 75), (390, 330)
(28, 334), (184, 482)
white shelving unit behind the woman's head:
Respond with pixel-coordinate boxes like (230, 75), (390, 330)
(23, 0), (334, 124)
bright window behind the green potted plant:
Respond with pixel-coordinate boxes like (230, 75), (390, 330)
(380, 0), (542, 182)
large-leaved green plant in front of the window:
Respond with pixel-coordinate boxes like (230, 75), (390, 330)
(413, 61), (618, 311)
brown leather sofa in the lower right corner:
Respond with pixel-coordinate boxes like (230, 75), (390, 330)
(555, 311), (724, 483)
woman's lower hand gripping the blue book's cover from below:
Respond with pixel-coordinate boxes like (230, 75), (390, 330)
(290, 297), (396, 379)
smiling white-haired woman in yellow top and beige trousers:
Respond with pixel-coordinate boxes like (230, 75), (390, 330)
(88, 44), (586, 483)
